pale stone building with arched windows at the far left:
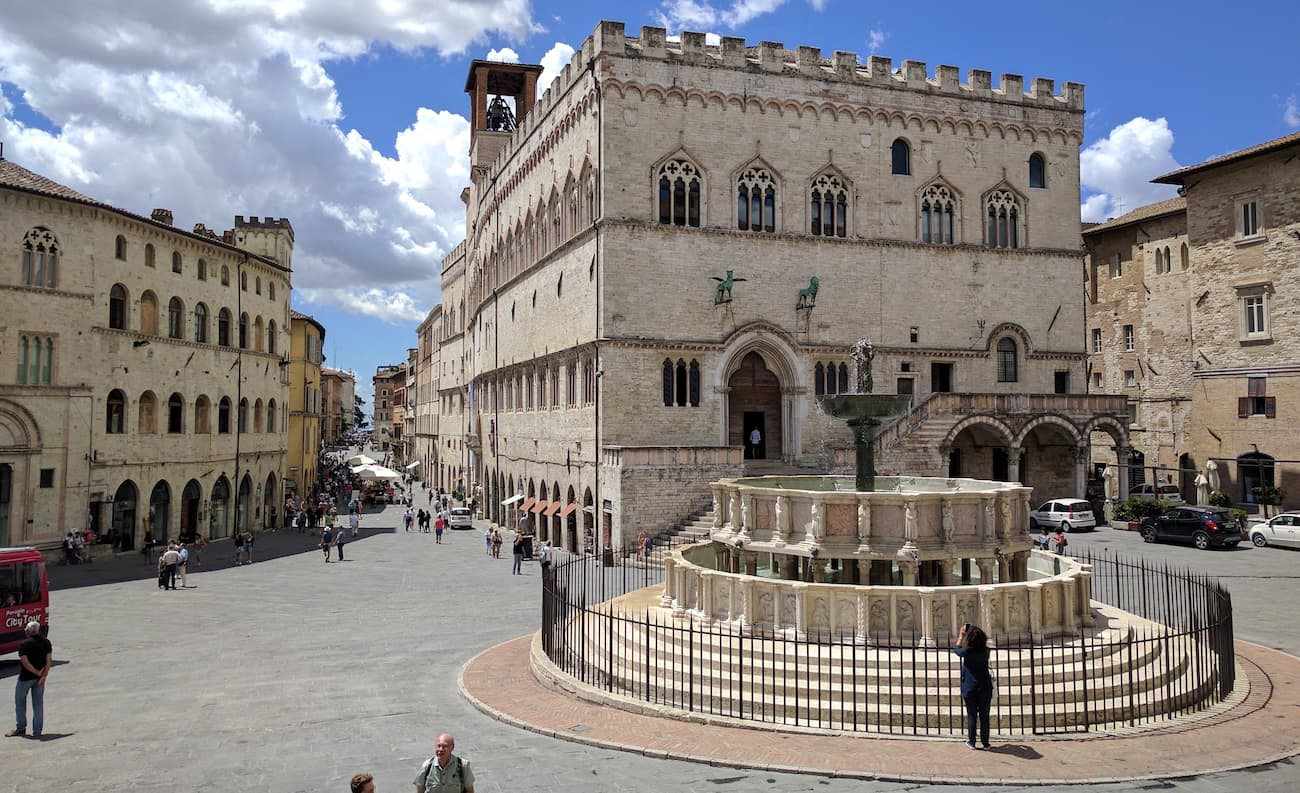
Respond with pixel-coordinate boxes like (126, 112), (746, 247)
(0, 152), (294, 550)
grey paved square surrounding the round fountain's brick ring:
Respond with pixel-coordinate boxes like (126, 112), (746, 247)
(0, 507), (1300, 793)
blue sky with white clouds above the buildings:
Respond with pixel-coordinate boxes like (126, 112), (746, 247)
(0, 0), (1300, 400)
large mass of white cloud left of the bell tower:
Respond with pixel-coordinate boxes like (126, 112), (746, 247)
(0, 0), (540, 321)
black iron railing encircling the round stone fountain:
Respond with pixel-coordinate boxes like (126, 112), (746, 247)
(542, 542), (1235, 736)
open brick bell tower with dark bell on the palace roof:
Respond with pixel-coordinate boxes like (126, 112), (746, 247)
(465, 60), (542, 178)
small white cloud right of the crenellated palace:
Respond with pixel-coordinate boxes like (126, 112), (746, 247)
(1079, 116), (1179, 221)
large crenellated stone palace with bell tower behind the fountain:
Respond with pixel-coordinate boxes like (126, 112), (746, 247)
(426, 22), (1128, 549)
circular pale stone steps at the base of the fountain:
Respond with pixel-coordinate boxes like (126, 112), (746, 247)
(559, 602), (1217, 736)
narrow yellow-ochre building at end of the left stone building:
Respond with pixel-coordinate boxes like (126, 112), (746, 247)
(285, 311), (325, 497)
